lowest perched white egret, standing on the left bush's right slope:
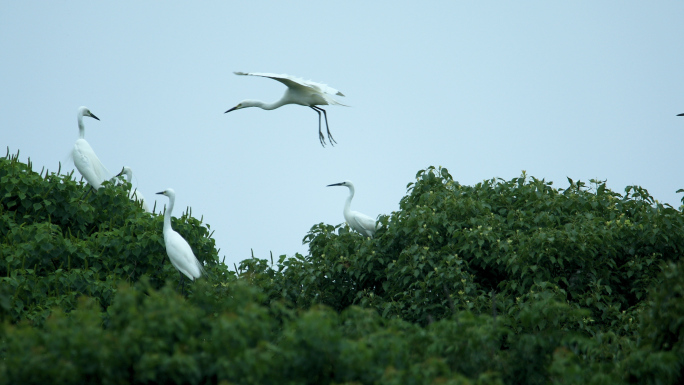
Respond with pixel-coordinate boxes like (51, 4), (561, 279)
(157, 188), (204, 292)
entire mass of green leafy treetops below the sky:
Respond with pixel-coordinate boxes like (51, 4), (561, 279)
(0, 151), (684, 384)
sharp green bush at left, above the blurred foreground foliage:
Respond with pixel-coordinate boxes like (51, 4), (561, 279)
(0, 150), (227, 325)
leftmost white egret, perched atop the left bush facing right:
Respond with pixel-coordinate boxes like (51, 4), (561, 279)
(71, 107), (111, 190)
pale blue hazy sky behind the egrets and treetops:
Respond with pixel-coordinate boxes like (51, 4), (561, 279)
(0, 0), (684, 266)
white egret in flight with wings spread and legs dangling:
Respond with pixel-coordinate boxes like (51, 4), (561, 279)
(224, 72), (348, 147)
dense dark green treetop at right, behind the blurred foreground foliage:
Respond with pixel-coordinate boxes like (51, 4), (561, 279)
(268, 168), (684, 334)
